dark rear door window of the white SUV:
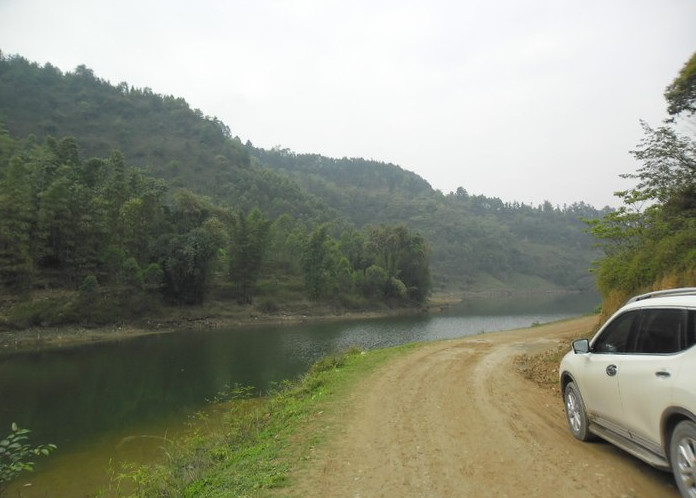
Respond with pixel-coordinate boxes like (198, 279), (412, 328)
(632, 309), (686, 354)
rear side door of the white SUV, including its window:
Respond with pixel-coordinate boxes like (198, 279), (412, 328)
(617, 308), (687, 454)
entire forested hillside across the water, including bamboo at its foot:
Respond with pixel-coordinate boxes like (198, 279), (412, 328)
(0, 53), (604, 326)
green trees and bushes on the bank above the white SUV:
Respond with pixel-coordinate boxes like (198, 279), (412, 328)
(590, 51), (696, 315)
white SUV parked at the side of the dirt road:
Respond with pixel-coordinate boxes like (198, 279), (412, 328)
(559, 288), (696, 498)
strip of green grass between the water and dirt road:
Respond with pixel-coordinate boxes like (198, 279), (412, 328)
(111, 344), (420, 497)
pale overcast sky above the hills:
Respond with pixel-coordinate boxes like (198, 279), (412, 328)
(0, 0), (696, 207)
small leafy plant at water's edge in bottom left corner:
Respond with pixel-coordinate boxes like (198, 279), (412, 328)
(0, 423), (56, 495)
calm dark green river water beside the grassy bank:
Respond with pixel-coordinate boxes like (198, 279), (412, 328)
(0, 294), (599, 496)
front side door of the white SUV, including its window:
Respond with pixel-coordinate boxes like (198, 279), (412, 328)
(576, 310), (639, 437)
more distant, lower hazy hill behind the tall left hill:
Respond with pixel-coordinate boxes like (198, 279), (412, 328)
(250, 148), (607, 289)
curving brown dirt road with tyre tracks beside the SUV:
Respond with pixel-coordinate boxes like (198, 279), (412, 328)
(288, 317), (679, 498)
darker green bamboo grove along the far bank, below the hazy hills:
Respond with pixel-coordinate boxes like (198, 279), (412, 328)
(0, 130), (430, 325)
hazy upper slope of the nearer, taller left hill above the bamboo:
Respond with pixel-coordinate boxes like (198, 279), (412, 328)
(0, 56), (250, 193)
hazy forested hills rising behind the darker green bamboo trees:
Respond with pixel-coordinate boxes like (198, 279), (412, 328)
(0, 50), (604, 290)
